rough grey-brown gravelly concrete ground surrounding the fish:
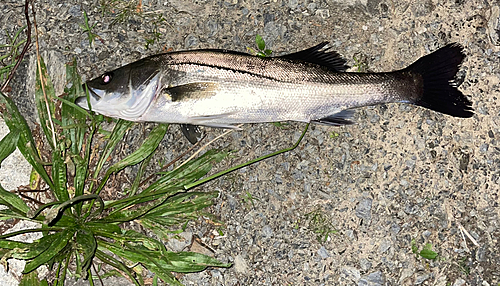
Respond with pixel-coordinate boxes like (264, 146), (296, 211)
(0, 0), (500, 286)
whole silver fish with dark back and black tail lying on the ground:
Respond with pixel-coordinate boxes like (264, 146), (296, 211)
(76, 42), (473, 131)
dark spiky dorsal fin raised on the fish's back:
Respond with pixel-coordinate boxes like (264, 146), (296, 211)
(279, 42), (349, 72)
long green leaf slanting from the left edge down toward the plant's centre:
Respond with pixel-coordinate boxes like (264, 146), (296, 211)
(0, 92), (54, 189)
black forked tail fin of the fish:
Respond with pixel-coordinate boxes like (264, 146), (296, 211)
(405, 43), (474, 118)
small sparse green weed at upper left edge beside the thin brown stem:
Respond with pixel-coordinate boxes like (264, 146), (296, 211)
(0, 26), (26, 86)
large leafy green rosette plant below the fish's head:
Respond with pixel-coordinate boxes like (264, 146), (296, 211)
(0, 59), (230, 285)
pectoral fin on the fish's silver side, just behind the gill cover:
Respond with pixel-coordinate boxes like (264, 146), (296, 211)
(166, 82), (219, 102)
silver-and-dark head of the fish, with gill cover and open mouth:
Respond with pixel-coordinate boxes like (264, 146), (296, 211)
(75, 58), (161, 121)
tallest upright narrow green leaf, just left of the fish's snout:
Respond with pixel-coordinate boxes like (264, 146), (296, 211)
(35, 57), (56, 149)
